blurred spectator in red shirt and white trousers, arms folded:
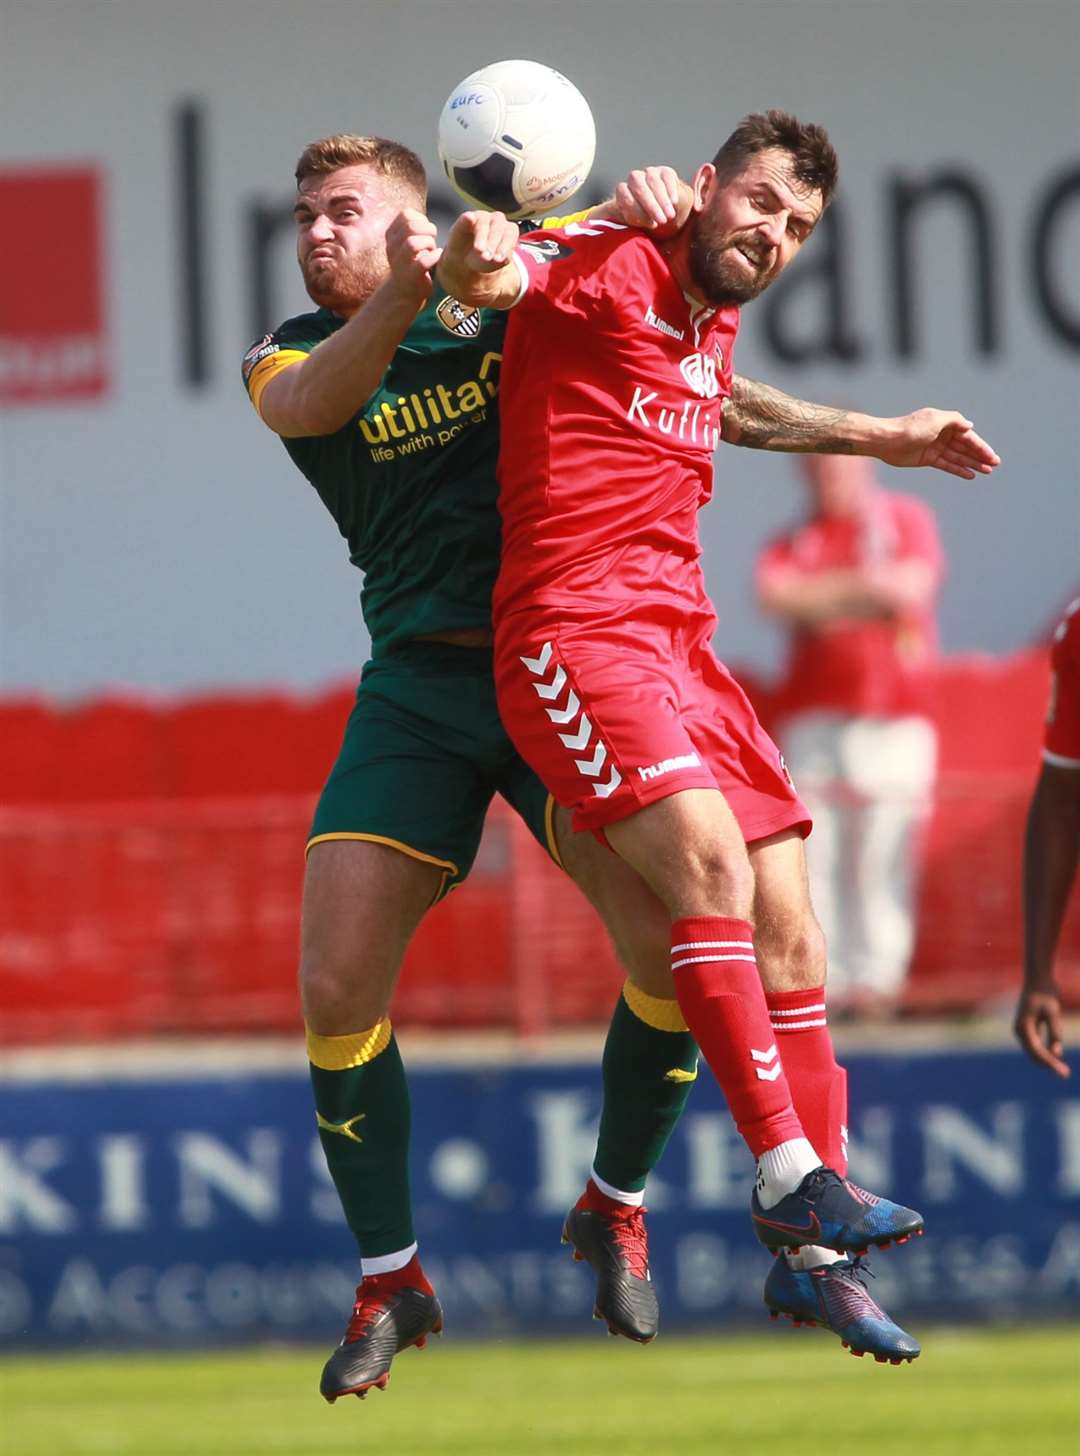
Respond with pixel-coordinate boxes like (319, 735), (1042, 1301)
(757, 456), (945, 1015)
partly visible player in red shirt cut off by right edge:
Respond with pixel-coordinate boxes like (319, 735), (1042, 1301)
(1013, 597), (1080, 1077)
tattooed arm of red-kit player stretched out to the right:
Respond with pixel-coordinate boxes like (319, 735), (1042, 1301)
(722, 374), (1001, 480)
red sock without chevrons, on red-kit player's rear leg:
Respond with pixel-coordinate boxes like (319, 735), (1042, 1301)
(766, 986), (847, 1178)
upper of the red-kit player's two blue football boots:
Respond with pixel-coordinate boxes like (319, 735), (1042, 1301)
(750, 1168), (923, 1254)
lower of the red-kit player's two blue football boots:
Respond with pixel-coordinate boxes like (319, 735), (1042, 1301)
(764, 1258), (920, 1364)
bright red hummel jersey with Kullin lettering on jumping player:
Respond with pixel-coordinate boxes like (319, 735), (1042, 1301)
(493, 221), (739, 622)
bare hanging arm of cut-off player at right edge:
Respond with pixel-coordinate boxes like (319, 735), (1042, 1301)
(1013, 763), (1080, 1077)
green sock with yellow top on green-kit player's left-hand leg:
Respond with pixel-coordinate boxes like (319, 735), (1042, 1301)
(307, 1021), (416, 1259)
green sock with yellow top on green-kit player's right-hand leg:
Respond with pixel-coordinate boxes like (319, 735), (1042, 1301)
(594, 981), (697, 1192)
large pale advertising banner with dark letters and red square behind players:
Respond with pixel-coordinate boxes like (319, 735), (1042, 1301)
(0, 0), (1080, 696)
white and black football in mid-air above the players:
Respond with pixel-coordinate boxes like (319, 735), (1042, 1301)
(438, 61), (597, 221)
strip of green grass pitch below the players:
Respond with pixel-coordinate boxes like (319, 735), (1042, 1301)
(0, 1326), (1080, 1456)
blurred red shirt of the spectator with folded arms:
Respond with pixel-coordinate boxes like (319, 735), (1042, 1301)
(758, 491), (945, 718)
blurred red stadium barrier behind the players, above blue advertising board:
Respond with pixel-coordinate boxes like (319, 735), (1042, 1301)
(0, 654), (1080, 1044)
